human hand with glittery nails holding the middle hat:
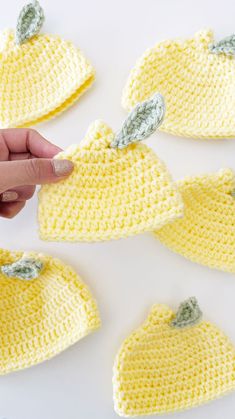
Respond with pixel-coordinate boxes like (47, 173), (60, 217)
(0, 128), (73, 218)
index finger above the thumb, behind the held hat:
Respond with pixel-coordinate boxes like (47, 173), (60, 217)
(0, 128), (61, 158)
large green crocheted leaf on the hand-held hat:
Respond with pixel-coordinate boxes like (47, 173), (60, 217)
(111, 93), (165, 148)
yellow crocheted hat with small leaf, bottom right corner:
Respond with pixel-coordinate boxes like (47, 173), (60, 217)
(113, 298), (235, 416)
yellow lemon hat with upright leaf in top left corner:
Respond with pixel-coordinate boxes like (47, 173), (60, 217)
(0, 2), (94, 128)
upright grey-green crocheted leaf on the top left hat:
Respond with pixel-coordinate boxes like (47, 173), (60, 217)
(15, 1), (45, 45)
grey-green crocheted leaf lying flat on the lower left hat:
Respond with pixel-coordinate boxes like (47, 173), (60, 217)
(1, 257), (43, 280)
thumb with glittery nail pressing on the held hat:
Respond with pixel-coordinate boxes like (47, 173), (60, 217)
(0, 159), (74, 192)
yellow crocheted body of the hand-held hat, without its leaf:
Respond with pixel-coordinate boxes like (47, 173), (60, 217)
(38, 121), (183, 241)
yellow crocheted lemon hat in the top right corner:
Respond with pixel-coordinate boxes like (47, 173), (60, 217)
(122, 30), (235, 138)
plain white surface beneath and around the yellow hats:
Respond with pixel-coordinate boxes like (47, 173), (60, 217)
(0, 0), (235, 419)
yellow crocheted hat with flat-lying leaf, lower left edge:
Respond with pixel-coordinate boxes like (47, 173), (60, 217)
(0, 249), (100, 374)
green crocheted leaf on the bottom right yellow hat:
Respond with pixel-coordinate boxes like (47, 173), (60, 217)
(171, 297), (202, 329)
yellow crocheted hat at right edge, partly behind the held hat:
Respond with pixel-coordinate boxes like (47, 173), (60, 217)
(155, 169), (235, 272)
